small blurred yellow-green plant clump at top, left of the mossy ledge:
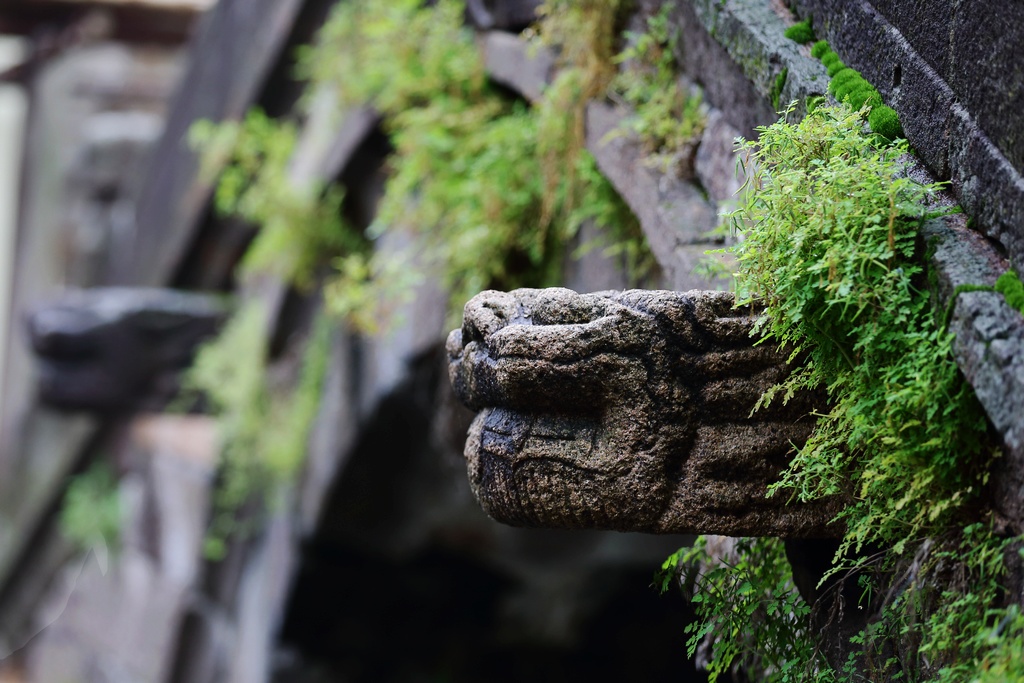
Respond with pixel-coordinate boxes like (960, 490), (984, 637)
(610, 5), (707, 176)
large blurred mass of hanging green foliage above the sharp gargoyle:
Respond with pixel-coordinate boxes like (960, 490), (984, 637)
(268, 0), (642, 331)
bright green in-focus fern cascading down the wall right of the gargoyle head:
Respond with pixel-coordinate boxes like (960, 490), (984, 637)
(663, 102), (1024, 681)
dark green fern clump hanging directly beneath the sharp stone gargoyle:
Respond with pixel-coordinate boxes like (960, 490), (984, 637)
(655, 537), (830, 683)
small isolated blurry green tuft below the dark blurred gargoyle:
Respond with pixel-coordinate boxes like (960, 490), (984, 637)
(60, 463), (121, 551)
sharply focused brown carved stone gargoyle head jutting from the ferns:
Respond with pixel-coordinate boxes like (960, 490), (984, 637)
(447, 289), (842, 539)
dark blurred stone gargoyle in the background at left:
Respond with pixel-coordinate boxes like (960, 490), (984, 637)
(26, 288), (228, 412)
